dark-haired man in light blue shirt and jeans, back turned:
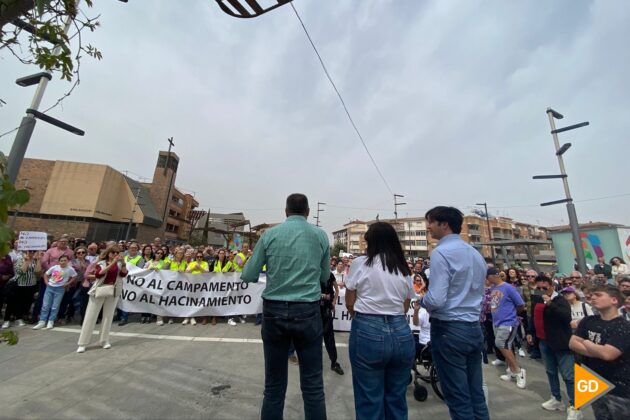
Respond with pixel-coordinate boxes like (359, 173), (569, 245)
(420, 206), (489, 420)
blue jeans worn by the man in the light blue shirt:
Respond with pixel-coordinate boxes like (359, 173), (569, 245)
(431, 318), (489, 420)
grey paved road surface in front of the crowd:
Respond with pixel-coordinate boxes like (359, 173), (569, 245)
(0, 323), (593, 420)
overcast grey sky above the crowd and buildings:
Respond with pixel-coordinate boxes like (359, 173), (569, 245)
(0, 0), (630, 232)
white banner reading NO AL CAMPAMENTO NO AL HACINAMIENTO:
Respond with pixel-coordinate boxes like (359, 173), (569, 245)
(118, 265), (265, 318)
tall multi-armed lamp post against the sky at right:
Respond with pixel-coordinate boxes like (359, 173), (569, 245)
(534, 108), (589, 274)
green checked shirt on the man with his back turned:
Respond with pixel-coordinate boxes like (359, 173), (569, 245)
(241, 216), (330, 302)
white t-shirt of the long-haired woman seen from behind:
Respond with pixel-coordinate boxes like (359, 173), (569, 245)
(346, 256), (416, 315)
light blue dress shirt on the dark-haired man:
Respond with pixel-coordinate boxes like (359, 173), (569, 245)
(421, 234), (487, 322)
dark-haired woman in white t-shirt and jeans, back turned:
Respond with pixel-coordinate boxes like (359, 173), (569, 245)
(346, 222), (416, 420)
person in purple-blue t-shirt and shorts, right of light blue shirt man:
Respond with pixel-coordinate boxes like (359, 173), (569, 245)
(486, 268), (527, 389)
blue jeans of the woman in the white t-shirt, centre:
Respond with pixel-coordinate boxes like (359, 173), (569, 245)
(349, 313), (416, 420)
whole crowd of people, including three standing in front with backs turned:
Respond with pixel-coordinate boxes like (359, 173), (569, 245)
(0, 194), (630, 420)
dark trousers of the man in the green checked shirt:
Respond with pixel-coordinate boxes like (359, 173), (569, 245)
(261, 300), (326, 420)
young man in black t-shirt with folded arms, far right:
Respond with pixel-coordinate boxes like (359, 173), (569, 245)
(569, 285), (630, 420)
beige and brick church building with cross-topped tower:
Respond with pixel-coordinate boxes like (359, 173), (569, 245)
(10, 152), (199, 242)
